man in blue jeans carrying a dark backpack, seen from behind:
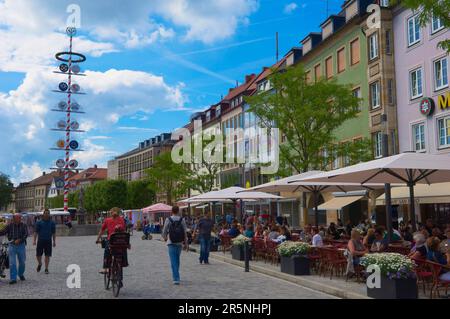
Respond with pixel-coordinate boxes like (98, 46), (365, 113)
(161, 206), (189, 285)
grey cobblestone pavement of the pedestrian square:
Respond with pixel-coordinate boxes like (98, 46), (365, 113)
(0, 233), (334, 299)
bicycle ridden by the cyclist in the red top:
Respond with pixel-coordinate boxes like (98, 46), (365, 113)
(102, 233), (130, 297)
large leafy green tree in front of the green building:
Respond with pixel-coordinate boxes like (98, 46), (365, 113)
(246, 65), (373, 175)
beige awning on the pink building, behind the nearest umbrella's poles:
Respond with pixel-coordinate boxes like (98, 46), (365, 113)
(377, 183), (450, 205)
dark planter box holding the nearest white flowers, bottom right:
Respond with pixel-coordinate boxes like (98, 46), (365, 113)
(367, 276), (418, 299)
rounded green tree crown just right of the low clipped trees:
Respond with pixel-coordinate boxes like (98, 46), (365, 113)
(146, 152), (192, 205)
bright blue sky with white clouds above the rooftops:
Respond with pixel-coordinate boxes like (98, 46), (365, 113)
(0, 0), (343, 185)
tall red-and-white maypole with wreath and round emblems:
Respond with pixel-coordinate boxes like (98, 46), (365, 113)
(52, 27), (86, 212)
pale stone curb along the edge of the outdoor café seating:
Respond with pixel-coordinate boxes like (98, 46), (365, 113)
(189, 247), (372, 299)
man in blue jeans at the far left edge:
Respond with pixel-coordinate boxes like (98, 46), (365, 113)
(0, 214), (28, 285)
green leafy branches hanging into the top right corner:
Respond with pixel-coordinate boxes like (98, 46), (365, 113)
(402, 0), (450, 53)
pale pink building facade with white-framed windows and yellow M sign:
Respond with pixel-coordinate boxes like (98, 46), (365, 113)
(393, 7), (450, 154)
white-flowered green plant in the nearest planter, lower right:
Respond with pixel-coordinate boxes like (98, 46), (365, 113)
(360, 253), (415, 279)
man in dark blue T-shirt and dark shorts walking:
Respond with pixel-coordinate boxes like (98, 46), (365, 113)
(33, 209), (56, 275)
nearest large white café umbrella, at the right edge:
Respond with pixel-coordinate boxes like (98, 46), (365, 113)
(298, 153), (450, 231)
